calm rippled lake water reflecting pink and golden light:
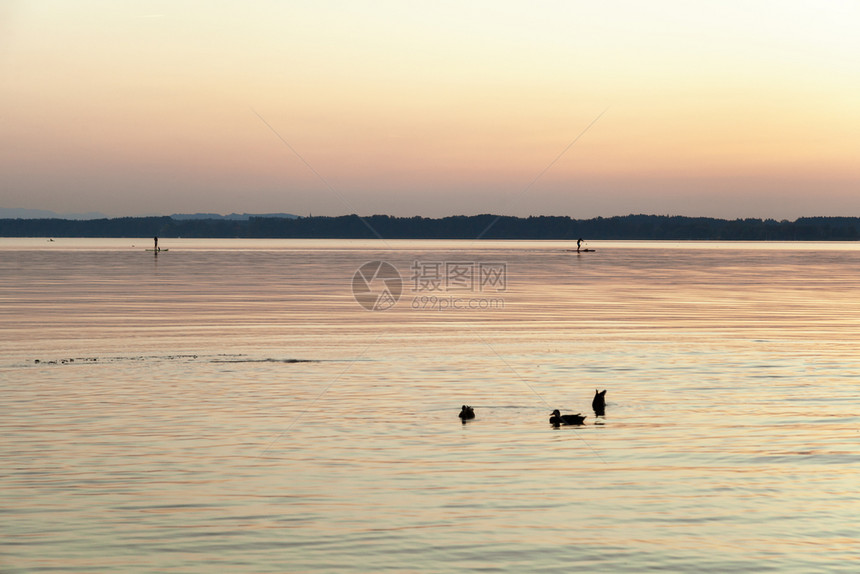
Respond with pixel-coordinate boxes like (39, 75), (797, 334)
(0, 238), (860, 572)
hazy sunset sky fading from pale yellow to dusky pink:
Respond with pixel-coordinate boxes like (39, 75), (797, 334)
(0, 0), (860, 219)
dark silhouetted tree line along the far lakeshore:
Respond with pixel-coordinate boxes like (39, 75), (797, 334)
(0, 214), (860, 241)
